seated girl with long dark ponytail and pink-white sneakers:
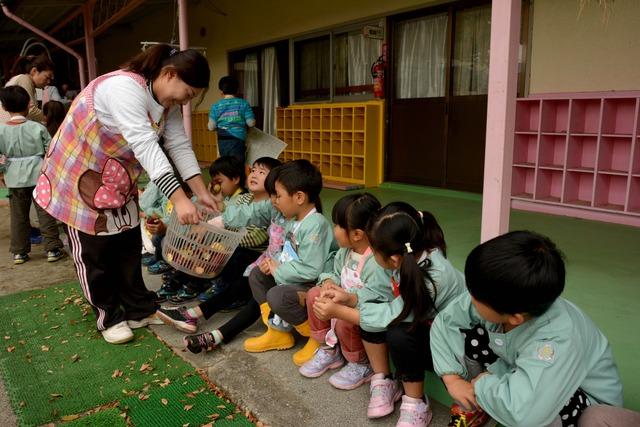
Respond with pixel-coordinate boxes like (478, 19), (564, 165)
(314, 203), (464, 426)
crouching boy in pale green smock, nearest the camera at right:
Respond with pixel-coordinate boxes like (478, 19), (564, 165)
(431, 231), (622, 426)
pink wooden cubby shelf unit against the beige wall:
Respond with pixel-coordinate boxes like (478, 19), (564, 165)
(511, 91), (640, 227)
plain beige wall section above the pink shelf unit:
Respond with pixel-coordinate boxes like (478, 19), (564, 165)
(529, 0), (640, 93)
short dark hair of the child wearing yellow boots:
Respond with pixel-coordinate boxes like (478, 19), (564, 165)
(276, 159), (322, 213)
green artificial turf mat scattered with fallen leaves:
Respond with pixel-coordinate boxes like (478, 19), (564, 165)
(0, 283), (255, 426)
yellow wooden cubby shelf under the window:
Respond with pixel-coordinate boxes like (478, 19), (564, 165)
(276, 101), (384, 187)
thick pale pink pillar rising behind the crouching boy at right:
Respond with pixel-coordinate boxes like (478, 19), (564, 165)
(480, 0), (521, 242)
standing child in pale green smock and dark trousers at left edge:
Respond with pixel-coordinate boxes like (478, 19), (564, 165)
(0, 86), (64, 264)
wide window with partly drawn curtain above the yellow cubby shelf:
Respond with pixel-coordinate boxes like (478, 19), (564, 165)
(293, 21), (384, 102)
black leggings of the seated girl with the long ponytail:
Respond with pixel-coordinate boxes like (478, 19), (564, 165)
(360, 322), (433, 382)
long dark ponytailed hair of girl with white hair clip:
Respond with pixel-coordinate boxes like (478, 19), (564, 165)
(367, 206), (436, 329)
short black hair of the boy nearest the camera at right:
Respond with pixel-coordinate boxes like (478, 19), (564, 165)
(464, 231), (565, 316)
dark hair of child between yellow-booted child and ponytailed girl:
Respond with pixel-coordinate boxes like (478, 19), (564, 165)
(331, 193), (382, 230)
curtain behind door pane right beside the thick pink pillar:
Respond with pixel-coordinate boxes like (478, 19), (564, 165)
(453, 5), (491, 95)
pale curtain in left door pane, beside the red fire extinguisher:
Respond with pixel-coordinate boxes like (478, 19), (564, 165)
(396, 13), (448, 98)
